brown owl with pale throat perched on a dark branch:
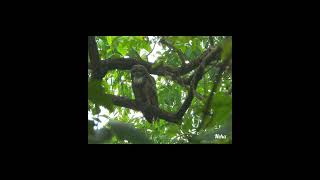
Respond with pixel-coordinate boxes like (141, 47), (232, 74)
(131, 65), (158, 123)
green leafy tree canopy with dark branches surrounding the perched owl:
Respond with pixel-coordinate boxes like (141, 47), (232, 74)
(88, 36), (232, 144)
